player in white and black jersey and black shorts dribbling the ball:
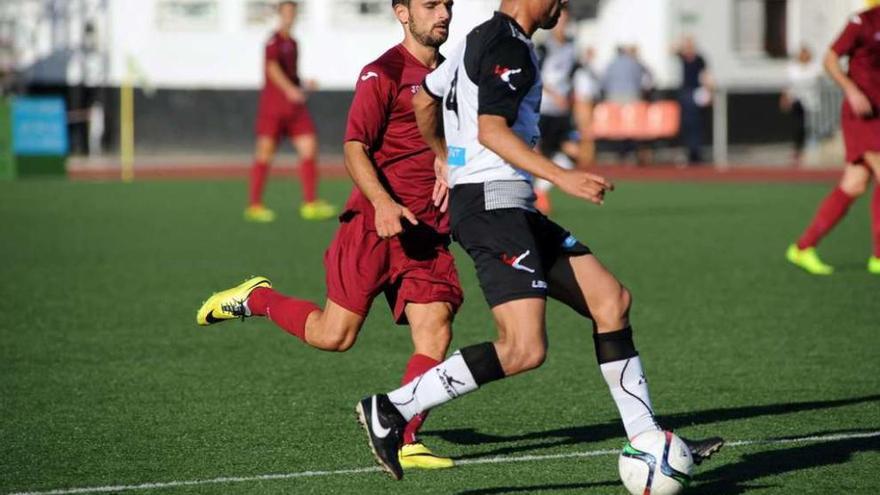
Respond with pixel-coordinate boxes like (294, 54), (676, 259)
(357, 0), (723, 479)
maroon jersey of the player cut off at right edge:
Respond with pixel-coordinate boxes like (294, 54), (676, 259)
(831, 7), (880, 108)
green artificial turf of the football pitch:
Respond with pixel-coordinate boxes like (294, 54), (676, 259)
(0, 180), (880, 495)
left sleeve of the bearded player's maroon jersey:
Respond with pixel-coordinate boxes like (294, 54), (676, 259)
(345, 66), (394, 148)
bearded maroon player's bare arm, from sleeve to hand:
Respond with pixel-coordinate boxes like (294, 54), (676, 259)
(343, 141), (419, 239)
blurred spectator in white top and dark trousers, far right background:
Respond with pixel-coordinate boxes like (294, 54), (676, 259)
(779, 46), (822, 167)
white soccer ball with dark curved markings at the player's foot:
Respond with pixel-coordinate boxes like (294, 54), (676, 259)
(617, 431), (694, 495)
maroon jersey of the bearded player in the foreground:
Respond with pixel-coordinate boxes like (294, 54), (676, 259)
(345, 45), (449, 234)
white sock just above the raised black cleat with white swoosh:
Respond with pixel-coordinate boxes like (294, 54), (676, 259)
(388, 351), (477, 421)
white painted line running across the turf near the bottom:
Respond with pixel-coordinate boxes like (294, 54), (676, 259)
(8, 431), (880, 495)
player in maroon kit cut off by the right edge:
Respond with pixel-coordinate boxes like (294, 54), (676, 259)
(786, 6), (880, 275)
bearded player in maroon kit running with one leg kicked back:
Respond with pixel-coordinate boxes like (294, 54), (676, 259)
(197, 0), (462, 469)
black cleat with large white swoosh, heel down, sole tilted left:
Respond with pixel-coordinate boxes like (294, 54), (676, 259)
(355, 394), (406, 480)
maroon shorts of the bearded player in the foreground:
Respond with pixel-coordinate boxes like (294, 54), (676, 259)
(324, 214), (463, 324)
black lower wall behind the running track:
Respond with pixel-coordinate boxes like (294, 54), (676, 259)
(29, 85), (791, 155)
